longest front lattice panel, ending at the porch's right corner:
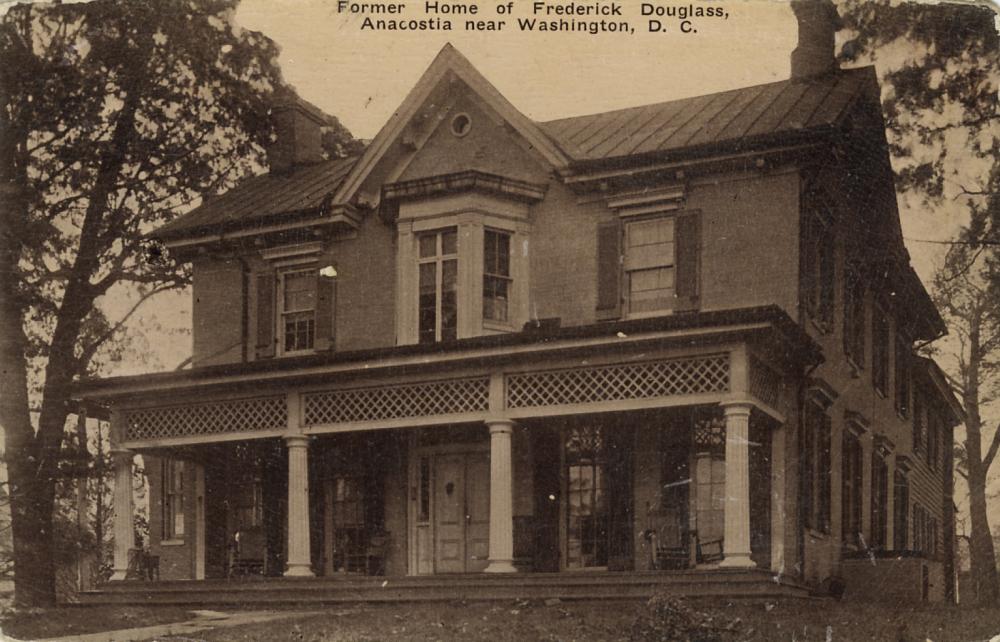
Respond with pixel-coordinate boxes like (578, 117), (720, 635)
(507, 354), (729, 408)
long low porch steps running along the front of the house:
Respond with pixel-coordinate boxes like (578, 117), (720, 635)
(77, 569), (809, 606)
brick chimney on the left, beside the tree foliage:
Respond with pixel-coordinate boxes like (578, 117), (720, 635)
(267, 91), (330, 174)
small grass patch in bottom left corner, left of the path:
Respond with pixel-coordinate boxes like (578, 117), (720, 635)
(0, 606), (194, 640)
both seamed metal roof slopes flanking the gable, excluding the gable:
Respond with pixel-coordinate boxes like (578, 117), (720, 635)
(155, 67), (877, 239)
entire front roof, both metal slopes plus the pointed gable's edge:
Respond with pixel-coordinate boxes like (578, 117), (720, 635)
(155, 45), (878, 241)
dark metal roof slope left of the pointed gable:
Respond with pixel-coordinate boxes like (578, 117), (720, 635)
(155, 156), (358, 238)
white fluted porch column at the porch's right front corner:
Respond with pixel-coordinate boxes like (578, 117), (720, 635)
(719, 402), (754, 568)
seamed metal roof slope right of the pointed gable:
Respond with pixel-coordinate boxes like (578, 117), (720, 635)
(540, 68), (874, 161)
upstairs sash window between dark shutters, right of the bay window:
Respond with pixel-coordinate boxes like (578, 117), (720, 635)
(625, 217), (676, 314)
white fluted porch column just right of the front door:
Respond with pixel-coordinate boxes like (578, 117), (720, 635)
(486, 419), (517, 573)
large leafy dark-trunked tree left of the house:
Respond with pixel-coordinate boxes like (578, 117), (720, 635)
(0, 0), (358, 605)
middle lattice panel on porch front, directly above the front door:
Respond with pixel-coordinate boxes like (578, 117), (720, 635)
(303, 377), (490, 426)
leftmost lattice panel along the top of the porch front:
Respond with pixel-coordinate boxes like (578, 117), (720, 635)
(125, 396), (288, 441)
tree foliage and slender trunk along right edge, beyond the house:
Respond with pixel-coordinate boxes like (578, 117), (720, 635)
(838, 0), (1000, 602)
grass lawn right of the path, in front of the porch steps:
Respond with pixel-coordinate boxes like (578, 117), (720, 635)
(154, 601), (1000, 642)
